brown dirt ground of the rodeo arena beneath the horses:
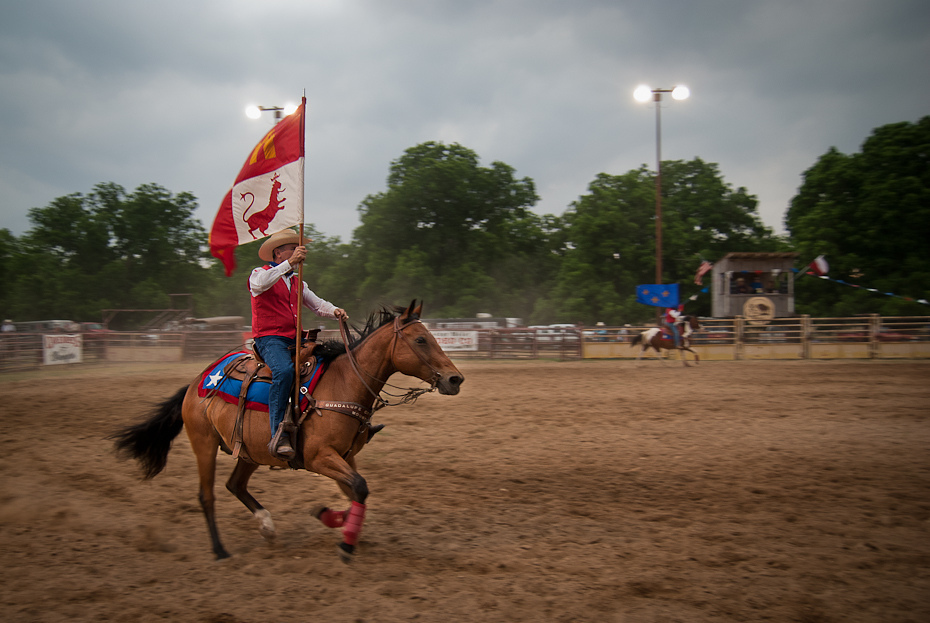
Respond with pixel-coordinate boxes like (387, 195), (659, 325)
(0, 361), (930, 623)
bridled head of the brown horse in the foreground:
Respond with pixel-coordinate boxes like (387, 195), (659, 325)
(391, 299), (465, 395)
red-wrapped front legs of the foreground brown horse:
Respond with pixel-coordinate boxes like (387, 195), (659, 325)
(307, 450), (368, 562)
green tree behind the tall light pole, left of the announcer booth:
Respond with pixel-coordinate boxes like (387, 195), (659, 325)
(549, 158), (785, 324)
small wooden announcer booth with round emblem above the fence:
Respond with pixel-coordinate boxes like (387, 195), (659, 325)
(711, 253), (798, 319)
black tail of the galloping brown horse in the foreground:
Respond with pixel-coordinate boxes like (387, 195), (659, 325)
(108, 386), (188, 480)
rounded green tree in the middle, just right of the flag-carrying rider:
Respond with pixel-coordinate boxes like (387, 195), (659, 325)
(352, 142), (554, 316)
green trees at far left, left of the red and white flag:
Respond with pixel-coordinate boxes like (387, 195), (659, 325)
(7, 183), (207, 320)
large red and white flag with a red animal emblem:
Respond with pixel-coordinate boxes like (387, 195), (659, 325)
(210, 98), (307, 277)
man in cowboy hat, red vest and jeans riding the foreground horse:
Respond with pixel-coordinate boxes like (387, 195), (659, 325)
(249, 229), (349, 459)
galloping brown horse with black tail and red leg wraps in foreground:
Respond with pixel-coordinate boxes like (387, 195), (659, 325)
(112, 301), (464, 561)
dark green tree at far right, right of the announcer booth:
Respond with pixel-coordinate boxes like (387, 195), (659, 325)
(785, 116), (930, 316)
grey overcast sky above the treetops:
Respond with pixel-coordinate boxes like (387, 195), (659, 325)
(0, 0), (930, 241)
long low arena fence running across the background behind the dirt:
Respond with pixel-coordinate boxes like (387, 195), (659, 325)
(0, 315), (930, 372)
